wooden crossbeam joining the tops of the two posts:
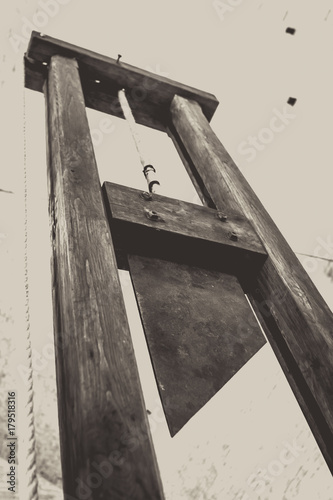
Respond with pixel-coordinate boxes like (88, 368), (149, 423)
(25, 31), (218, 130)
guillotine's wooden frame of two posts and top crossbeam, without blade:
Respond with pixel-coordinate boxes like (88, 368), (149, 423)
(25, 32), (333, 498)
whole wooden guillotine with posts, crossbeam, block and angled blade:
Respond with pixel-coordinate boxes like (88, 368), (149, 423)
(25, 32), (333, 500)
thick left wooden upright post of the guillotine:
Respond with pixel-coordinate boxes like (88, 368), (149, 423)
(44, 56), (163, 500)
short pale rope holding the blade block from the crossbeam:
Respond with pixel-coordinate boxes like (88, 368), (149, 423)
(118, 89), (160, 193)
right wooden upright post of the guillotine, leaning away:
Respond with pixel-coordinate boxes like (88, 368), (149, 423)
(171, 96), (333, 470)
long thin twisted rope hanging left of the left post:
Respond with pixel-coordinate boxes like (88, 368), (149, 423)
(21, 52), (38, 500)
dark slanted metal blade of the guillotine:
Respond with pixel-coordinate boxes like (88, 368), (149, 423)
(128, 255), (266, 436)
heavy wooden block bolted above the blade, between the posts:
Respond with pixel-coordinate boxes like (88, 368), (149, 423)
(103, 182), (267, 289)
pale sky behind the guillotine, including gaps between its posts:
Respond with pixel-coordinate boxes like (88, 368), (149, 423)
(0, 0), (333, 500)
